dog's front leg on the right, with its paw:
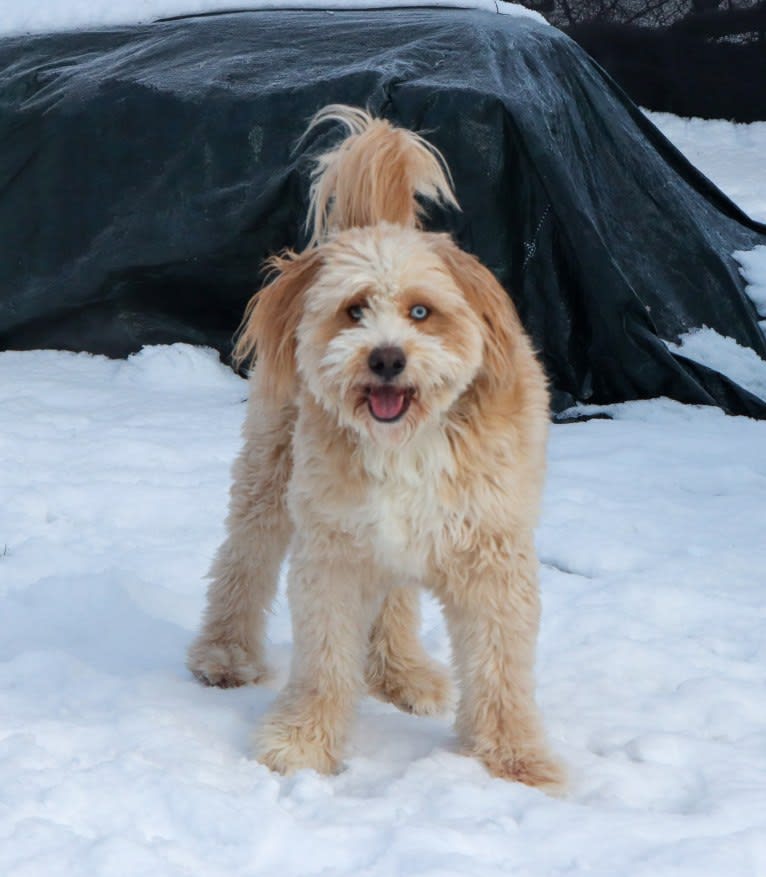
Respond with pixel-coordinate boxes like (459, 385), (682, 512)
(439, 533), (564, 792)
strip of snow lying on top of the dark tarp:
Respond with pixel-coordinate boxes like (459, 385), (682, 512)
(0, 0), (547, 36)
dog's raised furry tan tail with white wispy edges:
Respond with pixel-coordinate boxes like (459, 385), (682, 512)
(304, 104), (460, 245)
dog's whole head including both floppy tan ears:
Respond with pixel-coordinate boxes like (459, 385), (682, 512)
(237, 223), (520, 446)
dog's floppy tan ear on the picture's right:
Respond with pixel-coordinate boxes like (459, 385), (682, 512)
(434, 235), (526, 390)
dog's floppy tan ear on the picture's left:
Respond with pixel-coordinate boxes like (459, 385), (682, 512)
(233, 250), (322, 402)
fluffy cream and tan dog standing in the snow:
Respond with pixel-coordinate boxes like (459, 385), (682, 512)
(188, 106), (563, 790)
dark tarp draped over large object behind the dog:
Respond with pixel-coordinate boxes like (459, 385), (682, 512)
(0, 9), (766, 417)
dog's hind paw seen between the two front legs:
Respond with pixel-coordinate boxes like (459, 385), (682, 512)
(367, 661), (453, 716)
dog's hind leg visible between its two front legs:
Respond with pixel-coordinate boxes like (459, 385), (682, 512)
(366, 587), (452, 716)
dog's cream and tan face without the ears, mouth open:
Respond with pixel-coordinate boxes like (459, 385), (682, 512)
(296, 225), (483, 445)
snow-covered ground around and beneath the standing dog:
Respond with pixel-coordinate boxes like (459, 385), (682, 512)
(0, 77), (766, 877)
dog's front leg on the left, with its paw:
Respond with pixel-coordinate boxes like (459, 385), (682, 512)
(255, 528), (382, 774)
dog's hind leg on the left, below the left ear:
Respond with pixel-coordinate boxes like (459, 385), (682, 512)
(187, 394), (295, 688)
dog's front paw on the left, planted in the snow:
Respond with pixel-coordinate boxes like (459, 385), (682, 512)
(253, 715), (340, 775)
